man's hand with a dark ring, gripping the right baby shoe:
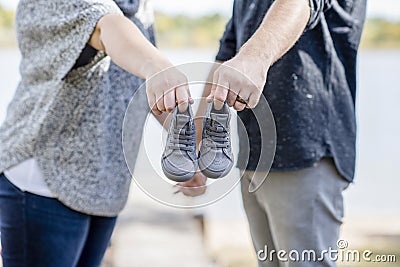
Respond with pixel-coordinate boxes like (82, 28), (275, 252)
(207, 50), (270, 110)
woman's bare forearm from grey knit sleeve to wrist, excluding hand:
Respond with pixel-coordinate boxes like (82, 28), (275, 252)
(89, 14), (171, 78)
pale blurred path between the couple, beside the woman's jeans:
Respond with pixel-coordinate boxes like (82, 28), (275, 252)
(106, 186), (214, 267)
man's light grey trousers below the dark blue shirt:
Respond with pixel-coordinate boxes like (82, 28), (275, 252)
(242, 158), (349, 267)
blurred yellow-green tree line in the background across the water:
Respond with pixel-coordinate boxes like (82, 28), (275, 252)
(0, 6), (400, 49)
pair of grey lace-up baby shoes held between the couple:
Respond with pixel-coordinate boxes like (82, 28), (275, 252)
(161, 102), (233, 182)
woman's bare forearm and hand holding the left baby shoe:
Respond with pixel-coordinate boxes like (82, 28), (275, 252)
(89, 14), (193, 115)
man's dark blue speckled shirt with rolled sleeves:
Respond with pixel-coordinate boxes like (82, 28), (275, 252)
(216, 0), (366, 181)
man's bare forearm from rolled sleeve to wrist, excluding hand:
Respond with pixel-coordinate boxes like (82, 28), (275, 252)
(239, 0), (310, 67)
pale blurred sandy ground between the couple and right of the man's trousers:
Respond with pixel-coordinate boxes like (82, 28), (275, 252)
(107, 182), (400, 267)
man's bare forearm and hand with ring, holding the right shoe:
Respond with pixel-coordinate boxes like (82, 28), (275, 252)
(208, 0), (310, 110)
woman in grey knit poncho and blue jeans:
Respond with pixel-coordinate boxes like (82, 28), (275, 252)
(0, 0), (192, 267)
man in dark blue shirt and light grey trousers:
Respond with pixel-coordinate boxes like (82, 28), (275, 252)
(193, 0), (366, 266)
